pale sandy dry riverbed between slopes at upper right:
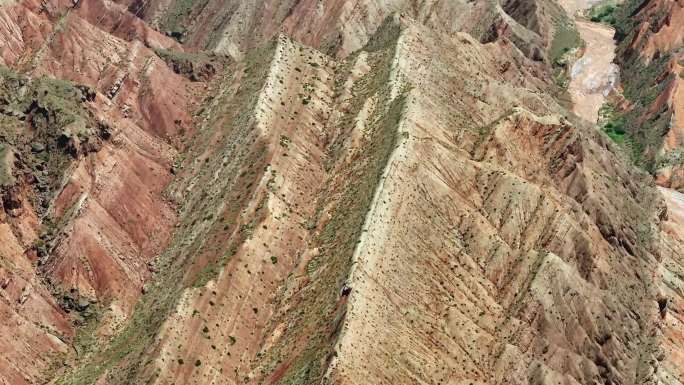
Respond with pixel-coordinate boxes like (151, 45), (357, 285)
(569, 20), (619, 122)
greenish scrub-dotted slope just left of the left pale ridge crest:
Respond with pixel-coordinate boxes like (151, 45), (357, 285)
(56, 38), (275, 385)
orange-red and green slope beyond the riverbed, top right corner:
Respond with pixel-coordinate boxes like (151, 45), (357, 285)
(616, 1), (684, 189)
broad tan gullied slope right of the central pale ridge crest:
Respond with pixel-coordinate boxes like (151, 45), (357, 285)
(330, 20), (662, 384)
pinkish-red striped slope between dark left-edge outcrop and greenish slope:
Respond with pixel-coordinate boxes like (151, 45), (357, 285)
(3, 0), (191, 311)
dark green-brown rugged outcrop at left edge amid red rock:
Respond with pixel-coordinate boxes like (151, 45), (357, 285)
(0, 66), (104, 213)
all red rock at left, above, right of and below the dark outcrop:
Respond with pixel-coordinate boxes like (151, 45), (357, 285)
(0, 0), (199, 385)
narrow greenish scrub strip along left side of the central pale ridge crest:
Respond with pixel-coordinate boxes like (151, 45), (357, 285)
(255, 19), (405, 384)
